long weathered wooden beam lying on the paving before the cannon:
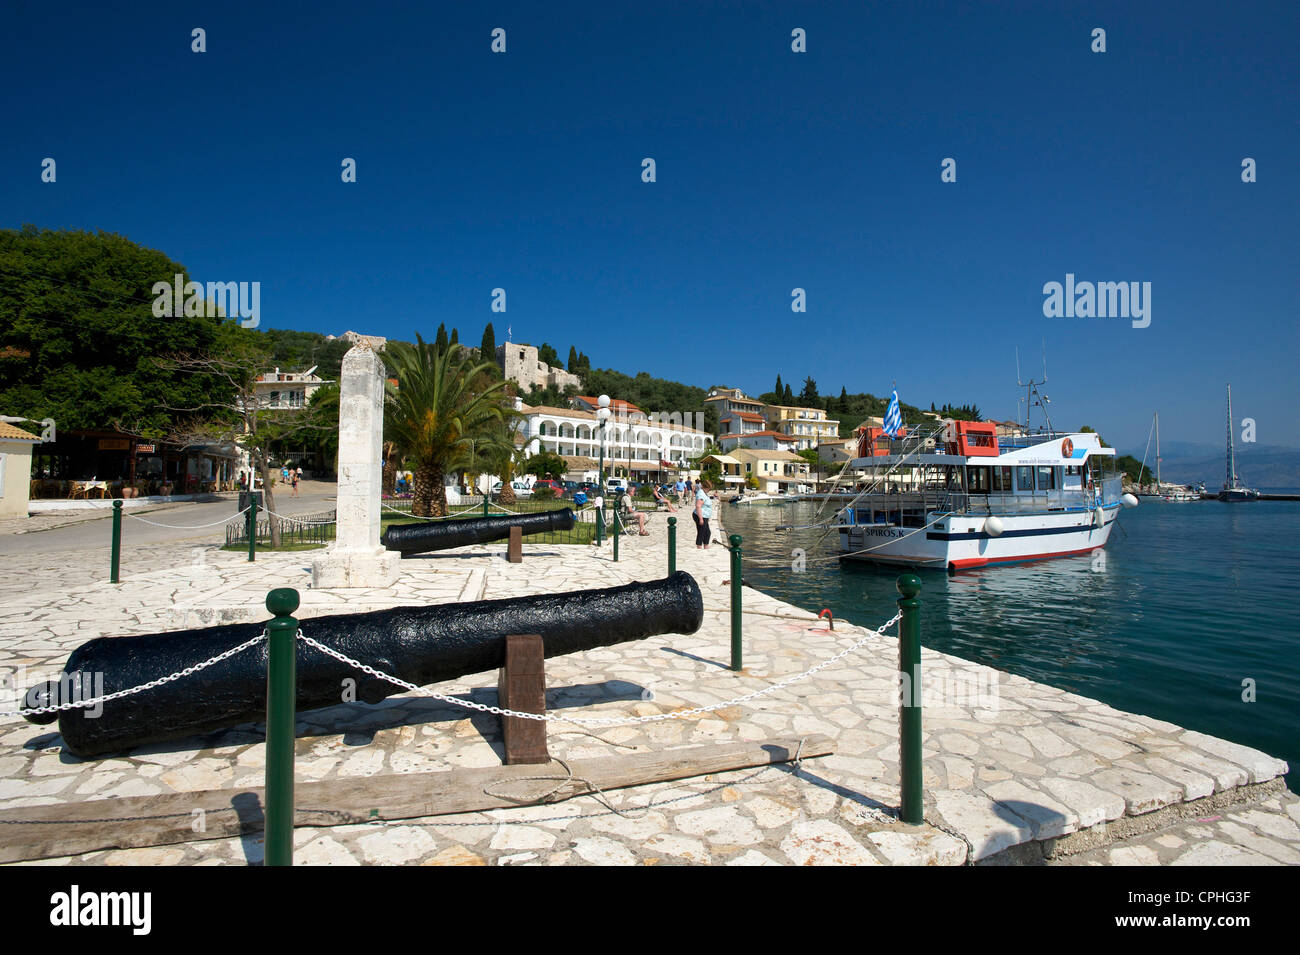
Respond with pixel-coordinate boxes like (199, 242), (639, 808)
(0, 734), (835, 863)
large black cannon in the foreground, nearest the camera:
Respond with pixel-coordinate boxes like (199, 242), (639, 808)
(26, 570), (705, 756)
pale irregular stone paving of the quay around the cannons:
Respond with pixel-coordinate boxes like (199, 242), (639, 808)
(0, 512), (1300, 865)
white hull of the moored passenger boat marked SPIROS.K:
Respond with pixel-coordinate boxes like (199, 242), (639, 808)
(840, 504), (1119, 570)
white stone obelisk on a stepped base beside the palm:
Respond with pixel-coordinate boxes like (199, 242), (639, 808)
(312, 340), (400, 589)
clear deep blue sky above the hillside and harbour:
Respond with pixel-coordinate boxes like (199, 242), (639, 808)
(0, 0), (1300, 452)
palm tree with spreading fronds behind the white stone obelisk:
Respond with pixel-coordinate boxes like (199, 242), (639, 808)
(385, 334), (507, 517)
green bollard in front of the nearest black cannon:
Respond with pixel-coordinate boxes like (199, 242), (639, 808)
(264, 587), (299, 865)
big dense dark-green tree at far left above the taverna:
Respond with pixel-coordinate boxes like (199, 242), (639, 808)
(0, 226), (231, 438)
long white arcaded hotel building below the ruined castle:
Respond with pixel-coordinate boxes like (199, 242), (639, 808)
(516, 401), (711, 481)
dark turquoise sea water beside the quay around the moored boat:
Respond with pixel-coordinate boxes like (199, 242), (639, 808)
(723, 499), (1300, 790)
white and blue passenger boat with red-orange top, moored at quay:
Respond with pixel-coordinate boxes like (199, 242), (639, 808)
(837, 421), (1138, 570)
